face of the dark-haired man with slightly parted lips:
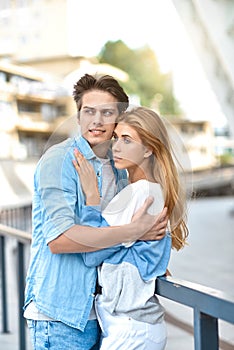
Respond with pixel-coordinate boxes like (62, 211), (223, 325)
(79, 90), (119, 148)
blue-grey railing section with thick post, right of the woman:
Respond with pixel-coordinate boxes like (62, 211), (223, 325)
(155, 277), (234, 350)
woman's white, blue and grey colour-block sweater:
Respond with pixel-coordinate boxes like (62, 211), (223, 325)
(85, 180), (171, 324)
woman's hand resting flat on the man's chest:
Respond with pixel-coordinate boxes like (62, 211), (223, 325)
(72, 148), (100, 205)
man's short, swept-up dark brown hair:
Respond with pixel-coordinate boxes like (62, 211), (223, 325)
(73, 74), (129, 113)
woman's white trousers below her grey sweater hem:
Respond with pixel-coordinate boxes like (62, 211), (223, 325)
(96, 302), (167, 350)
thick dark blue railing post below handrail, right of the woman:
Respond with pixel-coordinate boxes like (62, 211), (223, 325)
(194, 308), (219, 350)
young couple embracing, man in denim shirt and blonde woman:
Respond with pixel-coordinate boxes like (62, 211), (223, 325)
(24, 74), (188, 350)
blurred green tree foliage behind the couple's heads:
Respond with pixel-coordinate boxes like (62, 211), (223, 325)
(98, 40), (181, 115)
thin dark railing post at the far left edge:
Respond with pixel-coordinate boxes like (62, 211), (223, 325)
(0, 236), (9, 333)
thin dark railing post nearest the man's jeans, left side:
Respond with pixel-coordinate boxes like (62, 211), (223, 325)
(18, 242), (26, 350)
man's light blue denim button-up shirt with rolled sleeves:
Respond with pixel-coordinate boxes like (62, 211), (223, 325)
(24, 137), (127, 331)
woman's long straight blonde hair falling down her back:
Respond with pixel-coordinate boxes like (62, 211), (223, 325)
(116, 107), (188, 250)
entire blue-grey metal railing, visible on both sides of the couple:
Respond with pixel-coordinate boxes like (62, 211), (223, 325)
(0, 205), (234, 350)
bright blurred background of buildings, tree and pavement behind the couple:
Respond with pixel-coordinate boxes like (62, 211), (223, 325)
(0, 0), (234, 350)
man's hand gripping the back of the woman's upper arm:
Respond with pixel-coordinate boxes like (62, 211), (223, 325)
(139, 207), (168, 241)
